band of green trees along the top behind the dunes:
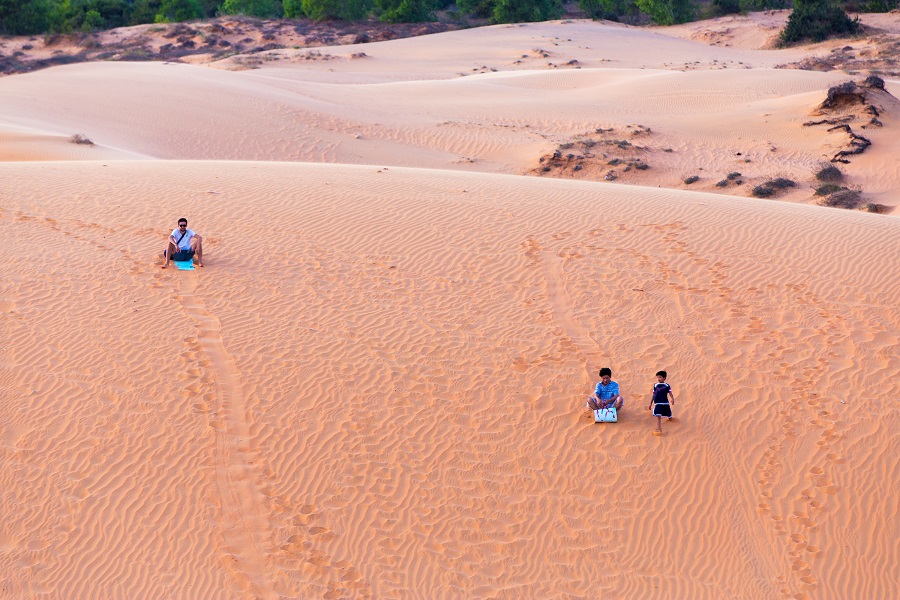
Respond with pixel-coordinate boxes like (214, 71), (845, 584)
(0, 0), (900, 42)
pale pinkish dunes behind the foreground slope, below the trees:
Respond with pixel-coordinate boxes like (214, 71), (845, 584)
(0, 18), (900, 213)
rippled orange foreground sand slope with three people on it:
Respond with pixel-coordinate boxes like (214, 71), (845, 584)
(0, 161), (900, 598)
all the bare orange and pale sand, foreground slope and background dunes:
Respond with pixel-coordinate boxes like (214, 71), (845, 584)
(0, 14), (900, 599)
